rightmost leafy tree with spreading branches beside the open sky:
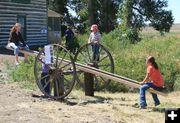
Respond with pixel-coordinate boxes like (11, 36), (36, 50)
(119, 0), (174, 42)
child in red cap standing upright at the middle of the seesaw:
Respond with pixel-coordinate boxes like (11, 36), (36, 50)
(88, 24), (101, 61)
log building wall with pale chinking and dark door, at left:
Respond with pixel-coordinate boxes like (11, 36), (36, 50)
(0, 0), (48, 46)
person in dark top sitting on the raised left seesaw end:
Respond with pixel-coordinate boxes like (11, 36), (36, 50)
(8, 23), (29, 65)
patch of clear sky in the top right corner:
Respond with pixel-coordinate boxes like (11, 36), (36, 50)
(167, 0), (180, 23)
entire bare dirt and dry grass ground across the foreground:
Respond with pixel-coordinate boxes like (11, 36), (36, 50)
(0, 55), (180, 123)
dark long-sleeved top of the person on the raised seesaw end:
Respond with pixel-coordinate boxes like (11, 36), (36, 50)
(9, 32), (26, 46)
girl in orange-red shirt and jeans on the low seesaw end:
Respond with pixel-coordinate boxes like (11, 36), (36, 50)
(140, 56), (164, 109)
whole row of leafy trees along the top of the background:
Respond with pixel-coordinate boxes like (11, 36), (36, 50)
(47, 0), (174, 40)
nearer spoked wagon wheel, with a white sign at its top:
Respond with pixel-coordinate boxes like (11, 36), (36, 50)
(34, 44), (76, 99)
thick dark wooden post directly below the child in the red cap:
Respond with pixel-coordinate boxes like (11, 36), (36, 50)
(84, 63), (94, 96)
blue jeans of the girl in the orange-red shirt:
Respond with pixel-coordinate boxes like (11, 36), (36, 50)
(140, 82), (160, 107)
